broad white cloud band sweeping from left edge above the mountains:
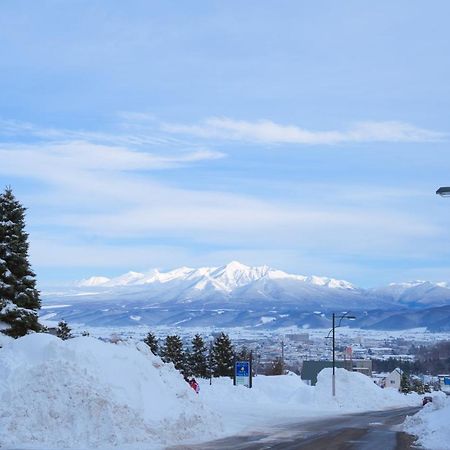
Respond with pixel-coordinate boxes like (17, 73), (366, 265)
(0, 135), (436, 255)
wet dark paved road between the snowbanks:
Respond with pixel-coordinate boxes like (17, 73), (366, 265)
(172, 408), (419, 450)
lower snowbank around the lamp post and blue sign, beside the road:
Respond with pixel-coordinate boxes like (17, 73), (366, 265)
(200, 368), (421, 432)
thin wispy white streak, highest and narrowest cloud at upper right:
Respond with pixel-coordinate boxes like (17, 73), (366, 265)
(162, 117), (447, 145)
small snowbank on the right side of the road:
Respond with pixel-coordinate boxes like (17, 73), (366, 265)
(403, 392), (450, 450)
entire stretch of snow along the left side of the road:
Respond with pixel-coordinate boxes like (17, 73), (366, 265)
(0, 334), (420, 450)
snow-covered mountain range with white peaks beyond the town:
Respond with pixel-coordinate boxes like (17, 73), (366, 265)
(44, 261), (450, 328)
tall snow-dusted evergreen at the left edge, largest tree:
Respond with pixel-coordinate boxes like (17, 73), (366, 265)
(0, 187), (42, 337)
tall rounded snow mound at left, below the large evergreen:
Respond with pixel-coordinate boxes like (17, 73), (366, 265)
(0, 334), (220, 449)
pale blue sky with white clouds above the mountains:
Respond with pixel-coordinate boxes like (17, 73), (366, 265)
(0, 0), (450, 286)
